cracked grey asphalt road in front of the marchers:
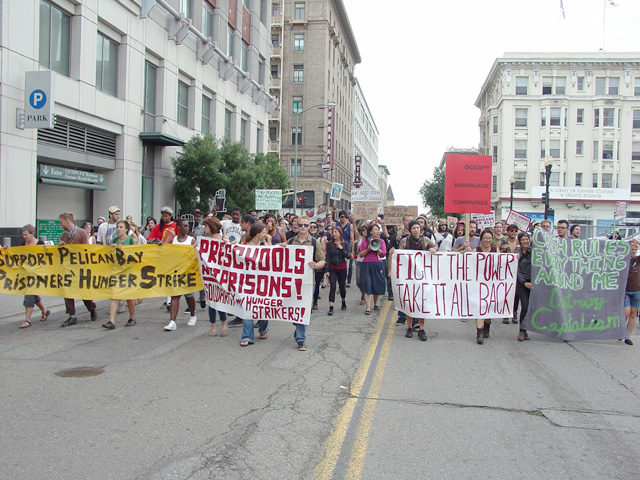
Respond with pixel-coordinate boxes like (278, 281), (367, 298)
(0, 288), (640, 479)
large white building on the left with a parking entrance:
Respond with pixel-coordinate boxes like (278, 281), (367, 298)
(0, 0), (276, 240)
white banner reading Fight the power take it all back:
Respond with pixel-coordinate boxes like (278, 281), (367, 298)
(391, 250), (518, 318)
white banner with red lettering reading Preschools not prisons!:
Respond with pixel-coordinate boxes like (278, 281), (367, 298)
(198, 237), (313, 325)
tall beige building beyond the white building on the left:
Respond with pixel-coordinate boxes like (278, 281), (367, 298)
(269, 0), (360, 208)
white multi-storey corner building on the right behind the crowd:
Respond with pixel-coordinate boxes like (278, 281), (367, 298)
(476, 52), (640, 230)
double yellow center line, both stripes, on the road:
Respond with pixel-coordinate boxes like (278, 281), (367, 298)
(313, 302), (395, 480)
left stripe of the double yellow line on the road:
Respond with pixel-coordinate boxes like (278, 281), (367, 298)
(313, 302), (393, 480)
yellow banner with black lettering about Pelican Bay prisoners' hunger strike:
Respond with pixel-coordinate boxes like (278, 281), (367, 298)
(0, 244), (202, 300)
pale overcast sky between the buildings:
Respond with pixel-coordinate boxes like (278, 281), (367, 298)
(343, 0), (640, 212)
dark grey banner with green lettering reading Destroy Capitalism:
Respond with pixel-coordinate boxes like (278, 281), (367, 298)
(522, 228), (630, 340)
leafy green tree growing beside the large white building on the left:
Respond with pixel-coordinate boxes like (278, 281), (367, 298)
(171, 134), (289, 212)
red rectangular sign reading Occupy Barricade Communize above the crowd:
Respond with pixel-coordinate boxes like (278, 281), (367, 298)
(444, 153), (491, 213)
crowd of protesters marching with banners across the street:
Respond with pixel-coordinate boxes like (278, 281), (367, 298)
(5, 202), (640, 350)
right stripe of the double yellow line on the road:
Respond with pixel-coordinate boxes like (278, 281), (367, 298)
(345, 311), (396, 479)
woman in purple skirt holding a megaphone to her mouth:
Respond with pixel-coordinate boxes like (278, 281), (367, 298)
(359, 223), (387, 315)
